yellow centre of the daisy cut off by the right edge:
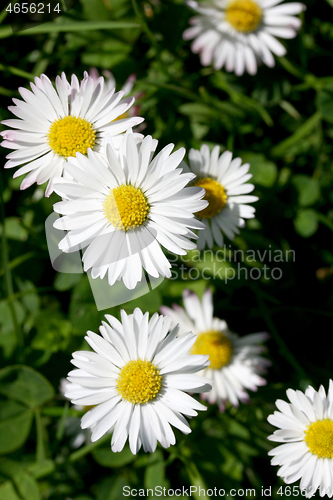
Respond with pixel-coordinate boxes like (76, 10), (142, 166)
(305, 418), (333, 458)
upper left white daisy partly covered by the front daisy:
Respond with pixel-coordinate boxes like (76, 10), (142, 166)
(1, 73), (143, 196)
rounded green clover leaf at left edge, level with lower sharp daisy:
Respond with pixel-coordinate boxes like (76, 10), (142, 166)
(0, 365), (54, 407)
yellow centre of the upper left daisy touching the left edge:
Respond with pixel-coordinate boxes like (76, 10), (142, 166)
(47, 116), (96, 158)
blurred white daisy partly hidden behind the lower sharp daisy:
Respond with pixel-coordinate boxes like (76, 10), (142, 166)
(161, 289), (270, 411)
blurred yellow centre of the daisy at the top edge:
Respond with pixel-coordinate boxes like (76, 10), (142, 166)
(225, 0), (262, 33)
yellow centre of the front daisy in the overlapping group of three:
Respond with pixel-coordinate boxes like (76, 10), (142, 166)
(103, 184), (149, 231)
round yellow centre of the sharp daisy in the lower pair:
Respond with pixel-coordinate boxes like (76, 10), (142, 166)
(117, 359), (162, 404)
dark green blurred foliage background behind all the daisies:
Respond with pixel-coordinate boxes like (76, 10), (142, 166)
(0, 0), (333, 500)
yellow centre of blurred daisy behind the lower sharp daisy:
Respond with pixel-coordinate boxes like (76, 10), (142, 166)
(191, 330), (232, 370)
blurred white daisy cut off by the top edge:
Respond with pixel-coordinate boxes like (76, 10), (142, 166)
(183, 0), (305, 76)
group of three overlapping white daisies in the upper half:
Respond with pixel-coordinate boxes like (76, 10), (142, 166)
(1, 72), (257, 289)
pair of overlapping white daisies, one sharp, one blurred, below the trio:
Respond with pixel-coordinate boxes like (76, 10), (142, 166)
(63, 290), (270, 454)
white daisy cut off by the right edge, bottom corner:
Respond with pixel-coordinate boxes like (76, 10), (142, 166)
(268, 380), (333, 498)
